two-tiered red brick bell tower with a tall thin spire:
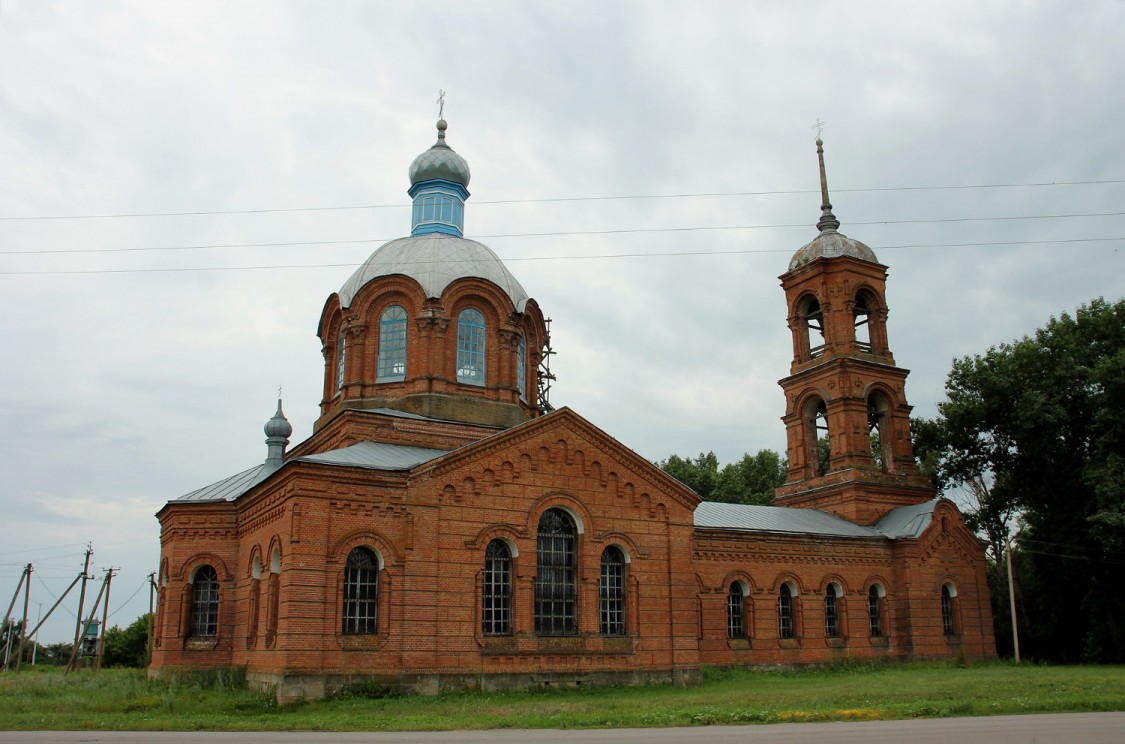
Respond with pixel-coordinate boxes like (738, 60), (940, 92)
(774, 138), (934, 525)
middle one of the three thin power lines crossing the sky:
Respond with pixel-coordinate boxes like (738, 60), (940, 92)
(0, 212), (1125, 256)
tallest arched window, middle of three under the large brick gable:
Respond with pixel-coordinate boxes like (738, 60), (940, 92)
(536, 509), (578, 636)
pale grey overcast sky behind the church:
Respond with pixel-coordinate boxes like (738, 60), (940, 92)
(0, 0), (1125, 642)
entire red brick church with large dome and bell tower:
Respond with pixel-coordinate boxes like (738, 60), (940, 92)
(150, 119), (996, 702)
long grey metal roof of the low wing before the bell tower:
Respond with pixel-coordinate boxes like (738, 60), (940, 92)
(695, 501), (883, 537)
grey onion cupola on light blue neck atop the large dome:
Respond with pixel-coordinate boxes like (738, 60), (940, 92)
(407, 119), (469, 237)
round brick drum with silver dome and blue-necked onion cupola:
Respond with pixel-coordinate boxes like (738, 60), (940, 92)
(314, 118), (549, 430)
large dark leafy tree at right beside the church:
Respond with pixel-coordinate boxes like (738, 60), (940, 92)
(916, 298), (1125, 662)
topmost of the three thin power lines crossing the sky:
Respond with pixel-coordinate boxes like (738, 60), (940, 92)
(0, 179), (1125, 222)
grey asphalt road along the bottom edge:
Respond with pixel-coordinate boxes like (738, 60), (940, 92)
(0, 712), (1125, 744)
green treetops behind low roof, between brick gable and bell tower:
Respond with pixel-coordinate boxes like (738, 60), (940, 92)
(656, 449), (786, 504)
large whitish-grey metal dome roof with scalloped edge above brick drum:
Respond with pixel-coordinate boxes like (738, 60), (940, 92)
(340, 233), (529, 313)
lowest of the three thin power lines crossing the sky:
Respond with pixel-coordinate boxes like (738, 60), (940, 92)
(0, 235), (1125, 276)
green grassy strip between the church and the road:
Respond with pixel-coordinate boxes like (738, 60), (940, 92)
(0, 663), (1125, 730)
